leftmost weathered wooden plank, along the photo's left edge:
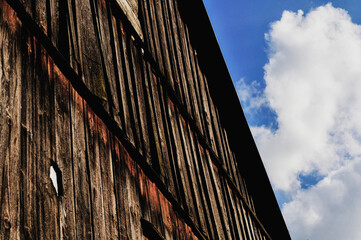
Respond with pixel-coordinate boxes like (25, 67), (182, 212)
(0, 7), (23, 239)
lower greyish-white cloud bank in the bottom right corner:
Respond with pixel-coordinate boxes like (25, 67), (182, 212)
(283, 159), (361, 240)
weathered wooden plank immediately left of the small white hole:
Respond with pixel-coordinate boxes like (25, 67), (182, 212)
(33, 41), (59, 239)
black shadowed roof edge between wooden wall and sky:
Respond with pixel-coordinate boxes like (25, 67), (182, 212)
(179, 0), (291, 239)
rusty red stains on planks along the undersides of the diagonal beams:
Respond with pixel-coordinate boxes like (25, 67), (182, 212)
(19, 30), (204, 239)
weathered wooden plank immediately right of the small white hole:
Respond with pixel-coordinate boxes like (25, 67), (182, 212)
(52, 62), (76, 239)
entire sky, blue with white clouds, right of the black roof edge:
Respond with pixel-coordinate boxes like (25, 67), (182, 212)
(204, 0), (361, 239)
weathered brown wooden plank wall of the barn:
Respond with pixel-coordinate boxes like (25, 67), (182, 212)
(0, 0), (270, 240)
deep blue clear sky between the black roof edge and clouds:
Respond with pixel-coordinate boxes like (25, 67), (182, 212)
(203, 0), (361, 127)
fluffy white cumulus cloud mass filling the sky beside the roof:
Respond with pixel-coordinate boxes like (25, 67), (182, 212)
(238, 4), (361, 239)
